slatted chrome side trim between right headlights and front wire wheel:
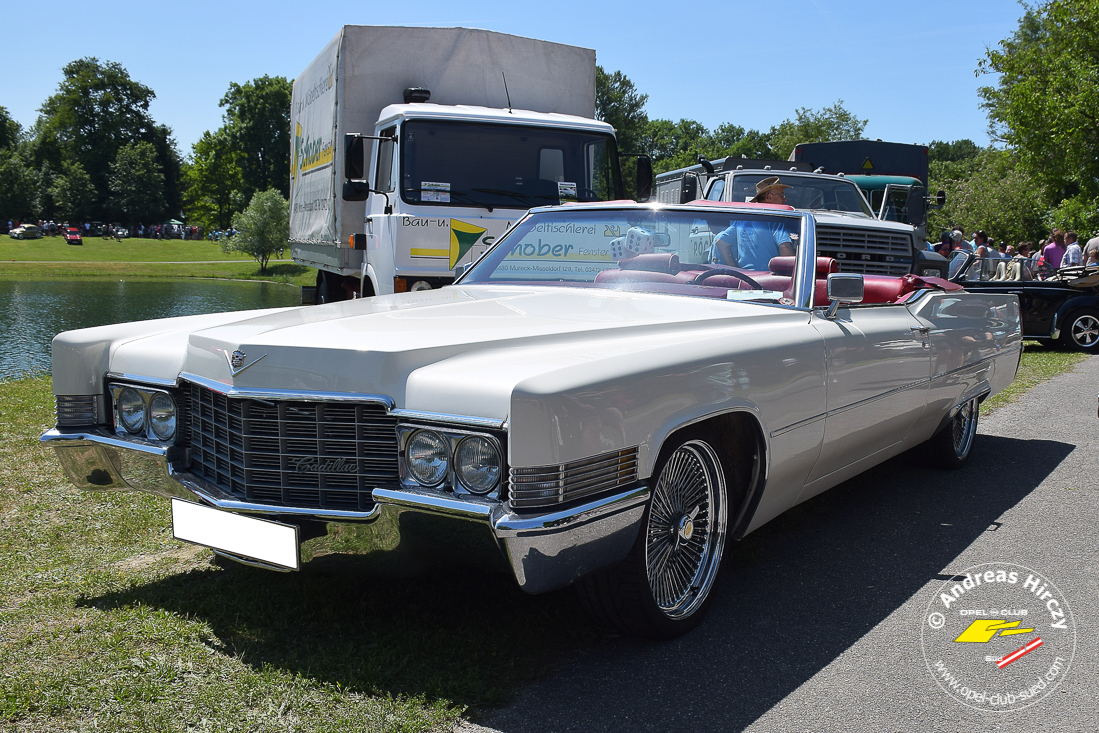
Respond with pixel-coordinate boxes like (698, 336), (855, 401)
(511, 447), (637, 509)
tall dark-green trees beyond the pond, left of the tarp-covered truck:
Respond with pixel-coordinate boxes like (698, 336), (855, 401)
(0, 57), (291, 230)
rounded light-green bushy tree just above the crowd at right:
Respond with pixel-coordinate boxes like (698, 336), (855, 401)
(928, 148), (1050, 244)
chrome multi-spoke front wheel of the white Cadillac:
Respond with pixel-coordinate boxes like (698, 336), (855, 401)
(645, 441), (726, 620)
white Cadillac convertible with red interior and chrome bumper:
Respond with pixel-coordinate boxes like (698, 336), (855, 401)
(42, 202), (1021, 636)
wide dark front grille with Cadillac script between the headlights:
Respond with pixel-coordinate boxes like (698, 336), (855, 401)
(184, 382), (398, 511)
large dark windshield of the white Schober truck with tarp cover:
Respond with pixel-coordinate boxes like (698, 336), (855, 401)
(400, 120), (623, 209)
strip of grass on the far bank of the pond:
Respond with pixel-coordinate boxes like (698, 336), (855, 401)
(0, 235), (317, 285)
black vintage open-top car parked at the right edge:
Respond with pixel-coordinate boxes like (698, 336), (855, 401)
(951, 249), (1099, 354)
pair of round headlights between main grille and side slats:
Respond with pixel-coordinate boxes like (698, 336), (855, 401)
(401, 426), (503, 495)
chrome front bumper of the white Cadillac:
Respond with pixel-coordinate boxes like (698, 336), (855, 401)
(41, 427), (648, 593)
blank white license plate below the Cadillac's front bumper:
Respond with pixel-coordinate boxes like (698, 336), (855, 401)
(171, 498), (300, 570)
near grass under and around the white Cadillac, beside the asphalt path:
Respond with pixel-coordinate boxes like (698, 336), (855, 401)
(0, 343), (1084, 732)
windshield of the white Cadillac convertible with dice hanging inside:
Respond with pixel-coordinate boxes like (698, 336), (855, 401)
(462, 208), (801, 303)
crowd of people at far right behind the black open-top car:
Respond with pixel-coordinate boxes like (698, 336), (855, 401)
(928, 226), (1099, 278)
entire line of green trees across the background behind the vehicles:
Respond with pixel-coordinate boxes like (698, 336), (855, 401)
(0, 0), (1099, 249)
